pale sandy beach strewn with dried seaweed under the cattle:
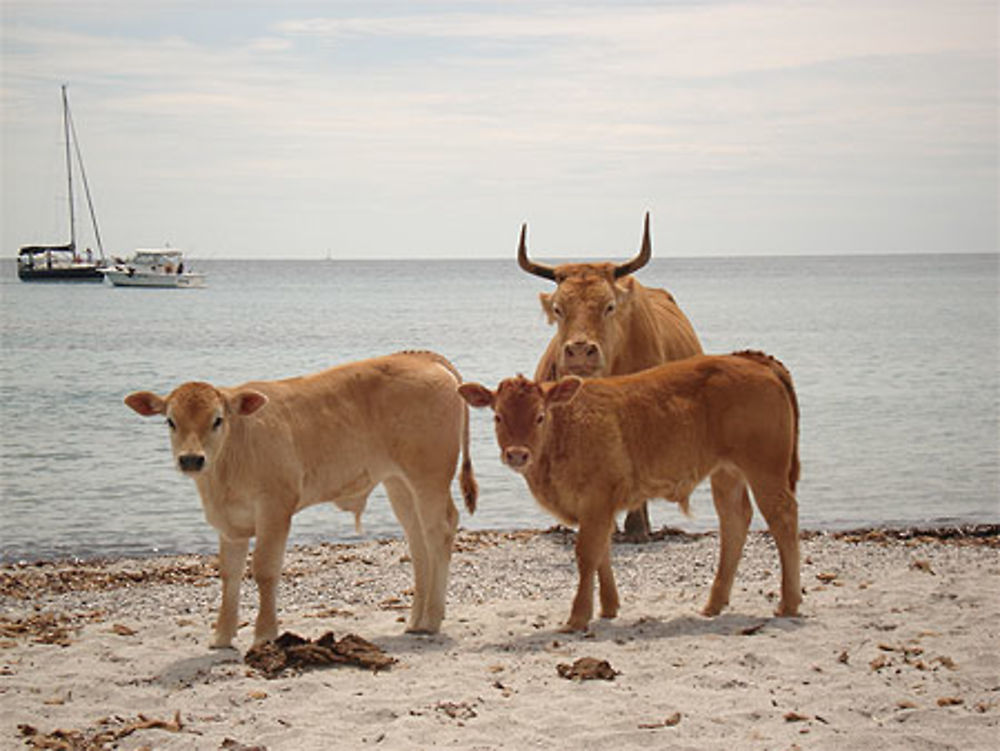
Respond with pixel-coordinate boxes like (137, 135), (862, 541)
(0, 529), (1000, 751)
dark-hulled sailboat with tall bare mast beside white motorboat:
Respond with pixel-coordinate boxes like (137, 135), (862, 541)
(17, 86), (106, 282)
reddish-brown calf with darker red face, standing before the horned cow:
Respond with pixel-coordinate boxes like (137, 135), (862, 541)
(459, 352), (802, 631)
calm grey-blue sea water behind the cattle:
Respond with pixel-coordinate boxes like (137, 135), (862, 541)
(0, 255), (1000, 561)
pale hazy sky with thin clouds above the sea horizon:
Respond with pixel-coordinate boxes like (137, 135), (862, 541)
(0, 0), (998, 259)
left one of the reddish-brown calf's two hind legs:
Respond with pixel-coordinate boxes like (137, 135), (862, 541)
(701, 469), (753, 616)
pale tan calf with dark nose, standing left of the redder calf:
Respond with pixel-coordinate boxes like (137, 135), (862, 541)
(125, 352), (477, 647)
